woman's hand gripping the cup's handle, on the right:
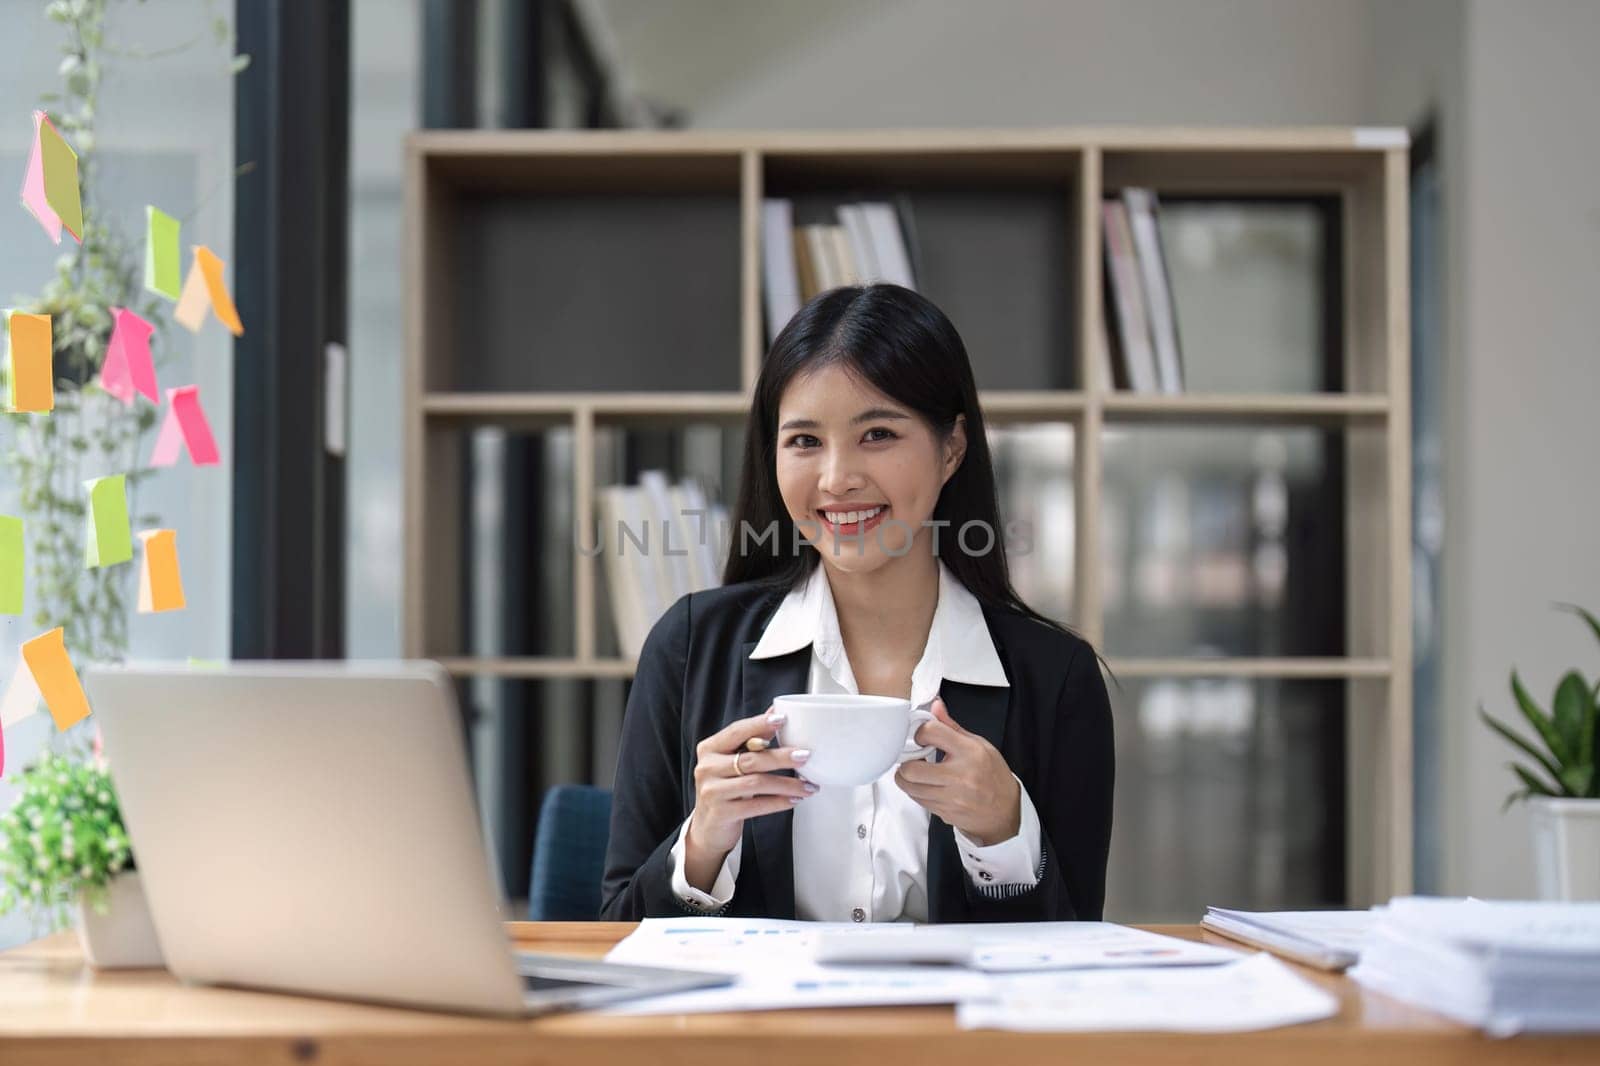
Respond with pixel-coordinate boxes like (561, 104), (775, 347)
(894, 698), (1022, 847)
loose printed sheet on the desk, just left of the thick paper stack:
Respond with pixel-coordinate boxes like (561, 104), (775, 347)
(955, 954), (1339, 1032)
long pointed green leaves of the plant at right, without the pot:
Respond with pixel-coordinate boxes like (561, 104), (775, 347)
(1478, 603), (1600, 807)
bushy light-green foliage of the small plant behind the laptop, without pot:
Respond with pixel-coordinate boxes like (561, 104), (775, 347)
(0, 751), (133, 928)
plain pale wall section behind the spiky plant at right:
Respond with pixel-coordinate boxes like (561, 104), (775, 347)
(1445, 0), (1600, 896)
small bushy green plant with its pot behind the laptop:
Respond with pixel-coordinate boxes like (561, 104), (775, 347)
(0, 739), (162, 968)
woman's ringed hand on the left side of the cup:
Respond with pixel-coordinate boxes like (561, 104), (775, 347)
(683, 707), (818, 892)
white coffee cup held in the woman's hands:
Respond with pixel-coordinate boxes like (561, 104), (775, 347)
(773, 693), (938, 787)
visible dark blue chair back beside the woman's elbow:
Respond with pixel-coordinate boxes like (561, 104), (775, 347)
(528, 784), (611, 922)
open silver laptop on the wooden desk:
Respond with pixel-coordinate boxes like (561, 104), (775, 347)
(86, 663), (730, 1015)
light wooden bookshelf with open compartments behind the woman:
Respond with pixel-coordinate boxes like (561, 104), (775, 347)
(403, 126), (1411, 904)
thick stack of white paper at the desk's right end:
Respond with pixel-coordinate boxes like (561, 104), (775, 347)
(1350, 896), (1600, 1036)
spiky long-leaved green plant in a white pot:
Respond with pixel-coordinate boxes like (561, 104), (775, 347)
(1478, 603), (1600, 900)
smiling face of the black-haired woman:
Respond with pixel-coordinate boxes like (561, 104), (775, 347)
(776, 363), (966, 573)
